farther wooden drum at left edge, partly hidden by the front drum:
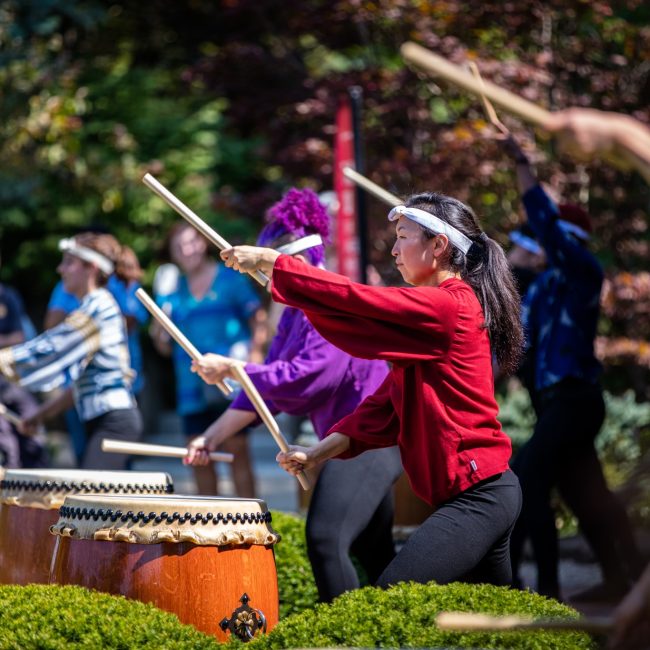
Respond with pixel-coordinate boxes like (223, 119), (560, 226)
(0, 469), (172, 585)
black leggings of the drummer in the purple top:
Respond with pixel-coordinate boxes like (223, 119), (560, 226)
(307, 447), (402, 602)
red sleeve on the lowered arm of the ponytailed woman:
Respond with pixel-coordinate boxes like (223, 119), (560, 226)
(326, 373), (400, 458)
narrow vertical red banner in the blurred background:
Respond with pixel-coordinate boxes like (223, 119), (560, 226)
(334, 97), (360, 282)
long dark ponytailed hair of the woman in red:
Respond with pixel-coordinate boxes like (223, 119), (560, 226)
(405, 192), (523, 373)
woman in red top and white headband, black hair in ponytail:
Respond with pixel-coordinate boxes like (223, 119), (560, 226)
(221, 193), (522, 587)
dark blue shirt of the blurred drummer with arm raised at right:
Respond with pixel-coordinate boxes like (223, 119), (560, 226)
(522, 185), (603, 390)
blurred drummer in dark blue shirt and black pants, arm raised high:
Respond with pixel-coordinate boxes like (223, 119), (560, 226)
(504, 136), (642, 601)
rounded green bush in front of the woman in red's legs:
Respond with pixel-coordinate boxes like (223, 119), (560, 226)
(242, 583), (597, 650)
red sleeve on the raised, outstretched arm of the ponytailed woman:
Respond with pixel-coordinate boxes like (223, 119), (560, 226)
(272, 255), (458, 363)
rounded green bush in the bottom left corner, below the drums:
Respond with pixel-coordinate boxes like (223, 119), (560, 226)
(0, 585), (220, 650)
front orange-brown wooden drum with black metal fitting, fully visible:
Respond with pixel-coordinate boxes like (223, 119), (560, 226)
(51, 496), (278, 641)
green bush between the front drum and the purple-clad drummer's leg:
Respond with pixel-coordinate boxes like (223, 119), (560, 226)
(272, 512), (318, 620)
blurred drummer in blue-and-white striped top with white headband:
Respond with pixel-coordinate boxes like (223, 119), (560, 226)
(0, 233), (142, 469)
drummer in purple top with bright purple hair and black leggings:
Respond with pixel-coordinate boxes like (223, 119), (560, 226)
(182, 189), (402, 602)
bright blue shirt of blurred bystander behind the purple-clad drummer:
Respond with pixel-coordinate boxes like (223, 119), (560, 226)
(156, 265), (260, 415)
